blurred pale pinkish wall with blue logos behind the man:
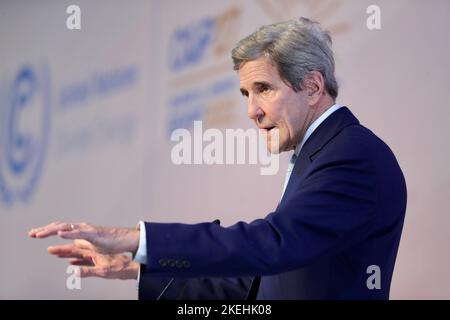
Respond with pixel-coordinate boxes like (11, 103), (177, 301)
(0, 0), (450, 299)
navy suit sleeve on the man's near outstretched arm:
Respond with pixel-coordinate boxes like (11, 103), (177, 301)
(140, 142), (377, 277)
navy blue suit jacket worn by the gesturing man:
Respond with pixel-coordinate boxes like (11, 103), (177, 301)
(139, 107), (406, 299)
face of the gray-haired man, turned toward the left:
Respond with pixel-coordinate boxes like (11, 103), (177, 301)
(239, 58), (311, 152)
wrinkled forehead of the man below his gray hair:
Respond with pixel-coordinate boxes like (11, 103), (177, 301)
(239, 58), (281, 88)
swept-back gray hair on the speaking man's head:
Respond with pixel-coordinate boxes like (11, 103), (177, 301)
(231, 17), (338, 99)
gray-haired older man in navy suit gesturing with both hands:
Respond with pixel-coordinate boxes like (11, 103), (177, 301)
(30, 18), (406, 299)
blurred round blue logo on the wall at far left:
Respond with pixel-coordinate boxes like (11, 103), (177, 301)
(0, 65), (50, 205)
